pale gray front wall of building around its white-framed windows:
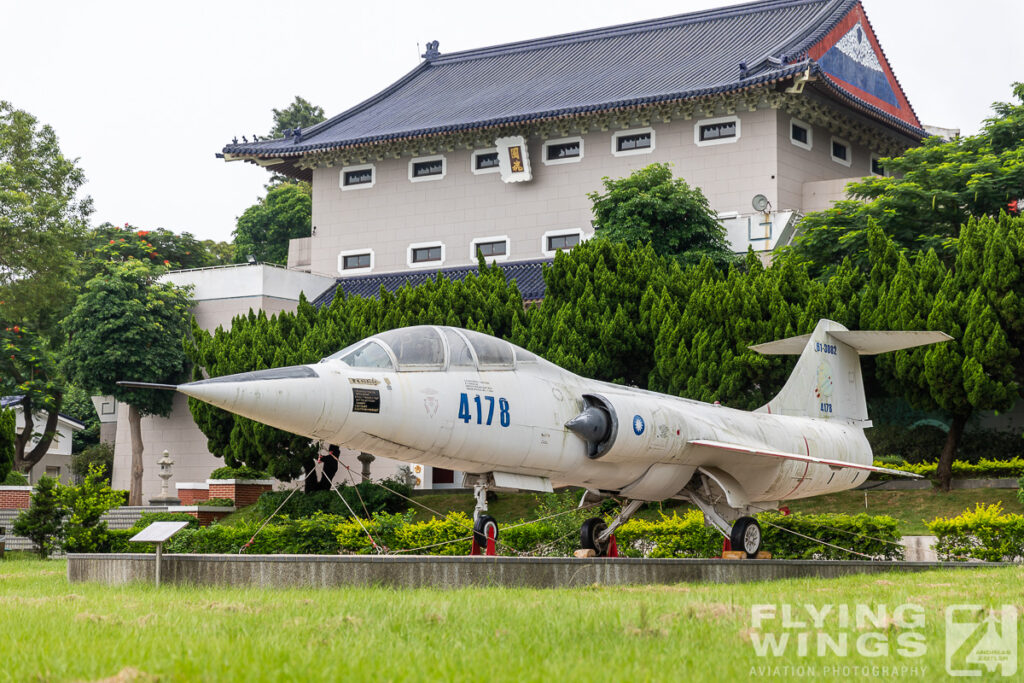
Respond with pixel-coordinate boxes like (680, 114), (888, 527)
(309, 110), (778, 274)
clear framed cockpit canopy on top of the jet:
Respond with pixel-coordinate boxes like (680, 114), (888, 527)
(321, 325), (538, 372)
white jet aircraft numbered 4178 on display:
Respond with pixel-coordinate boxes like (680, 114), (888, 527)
(124, 319), (950, 557)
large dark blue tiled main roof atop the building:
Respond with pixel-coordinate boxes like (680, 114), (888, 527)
(223, 0), (921, 158)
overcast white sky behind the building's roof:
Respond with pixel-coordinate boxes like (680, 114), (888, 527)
(0, 0), (1024, 240)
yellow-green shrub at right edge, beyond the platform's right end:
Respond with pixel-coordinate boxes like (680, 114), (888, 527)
(928, 503), (1024, 562)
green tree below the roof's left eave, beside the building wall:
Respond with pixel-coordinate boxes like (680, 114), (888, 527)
(231, 182), (312, 263)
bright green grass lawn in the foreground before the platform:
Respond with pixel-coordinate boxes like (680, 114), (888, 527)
(0, 559), (1024, 681)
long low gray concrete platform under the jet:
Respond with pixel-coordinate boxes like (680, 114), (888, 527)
(61, 553), (1007, 588)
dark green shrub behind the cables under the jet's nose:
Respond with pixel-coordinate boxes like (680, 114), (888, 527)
(256, 479), (413, 518)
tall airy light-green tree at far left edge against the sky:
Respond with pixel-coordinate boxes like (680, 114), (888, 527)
(0, 100), (92, 336)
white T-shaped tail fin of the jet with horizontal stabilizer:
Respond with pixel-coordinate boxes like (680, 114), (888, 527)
(751, 319), (952, 426)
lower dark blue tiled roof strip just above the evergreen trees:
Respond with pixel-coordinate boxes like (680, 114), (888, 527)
(312, 259), (551, 308)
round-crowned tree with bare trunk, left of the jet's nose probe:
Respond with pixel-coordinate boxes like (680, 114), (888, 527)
(63, 259), (191, 505)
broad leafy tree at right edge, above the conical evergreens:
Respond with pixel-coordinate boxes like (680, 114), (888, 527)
(794, 83), (1024, 274)
